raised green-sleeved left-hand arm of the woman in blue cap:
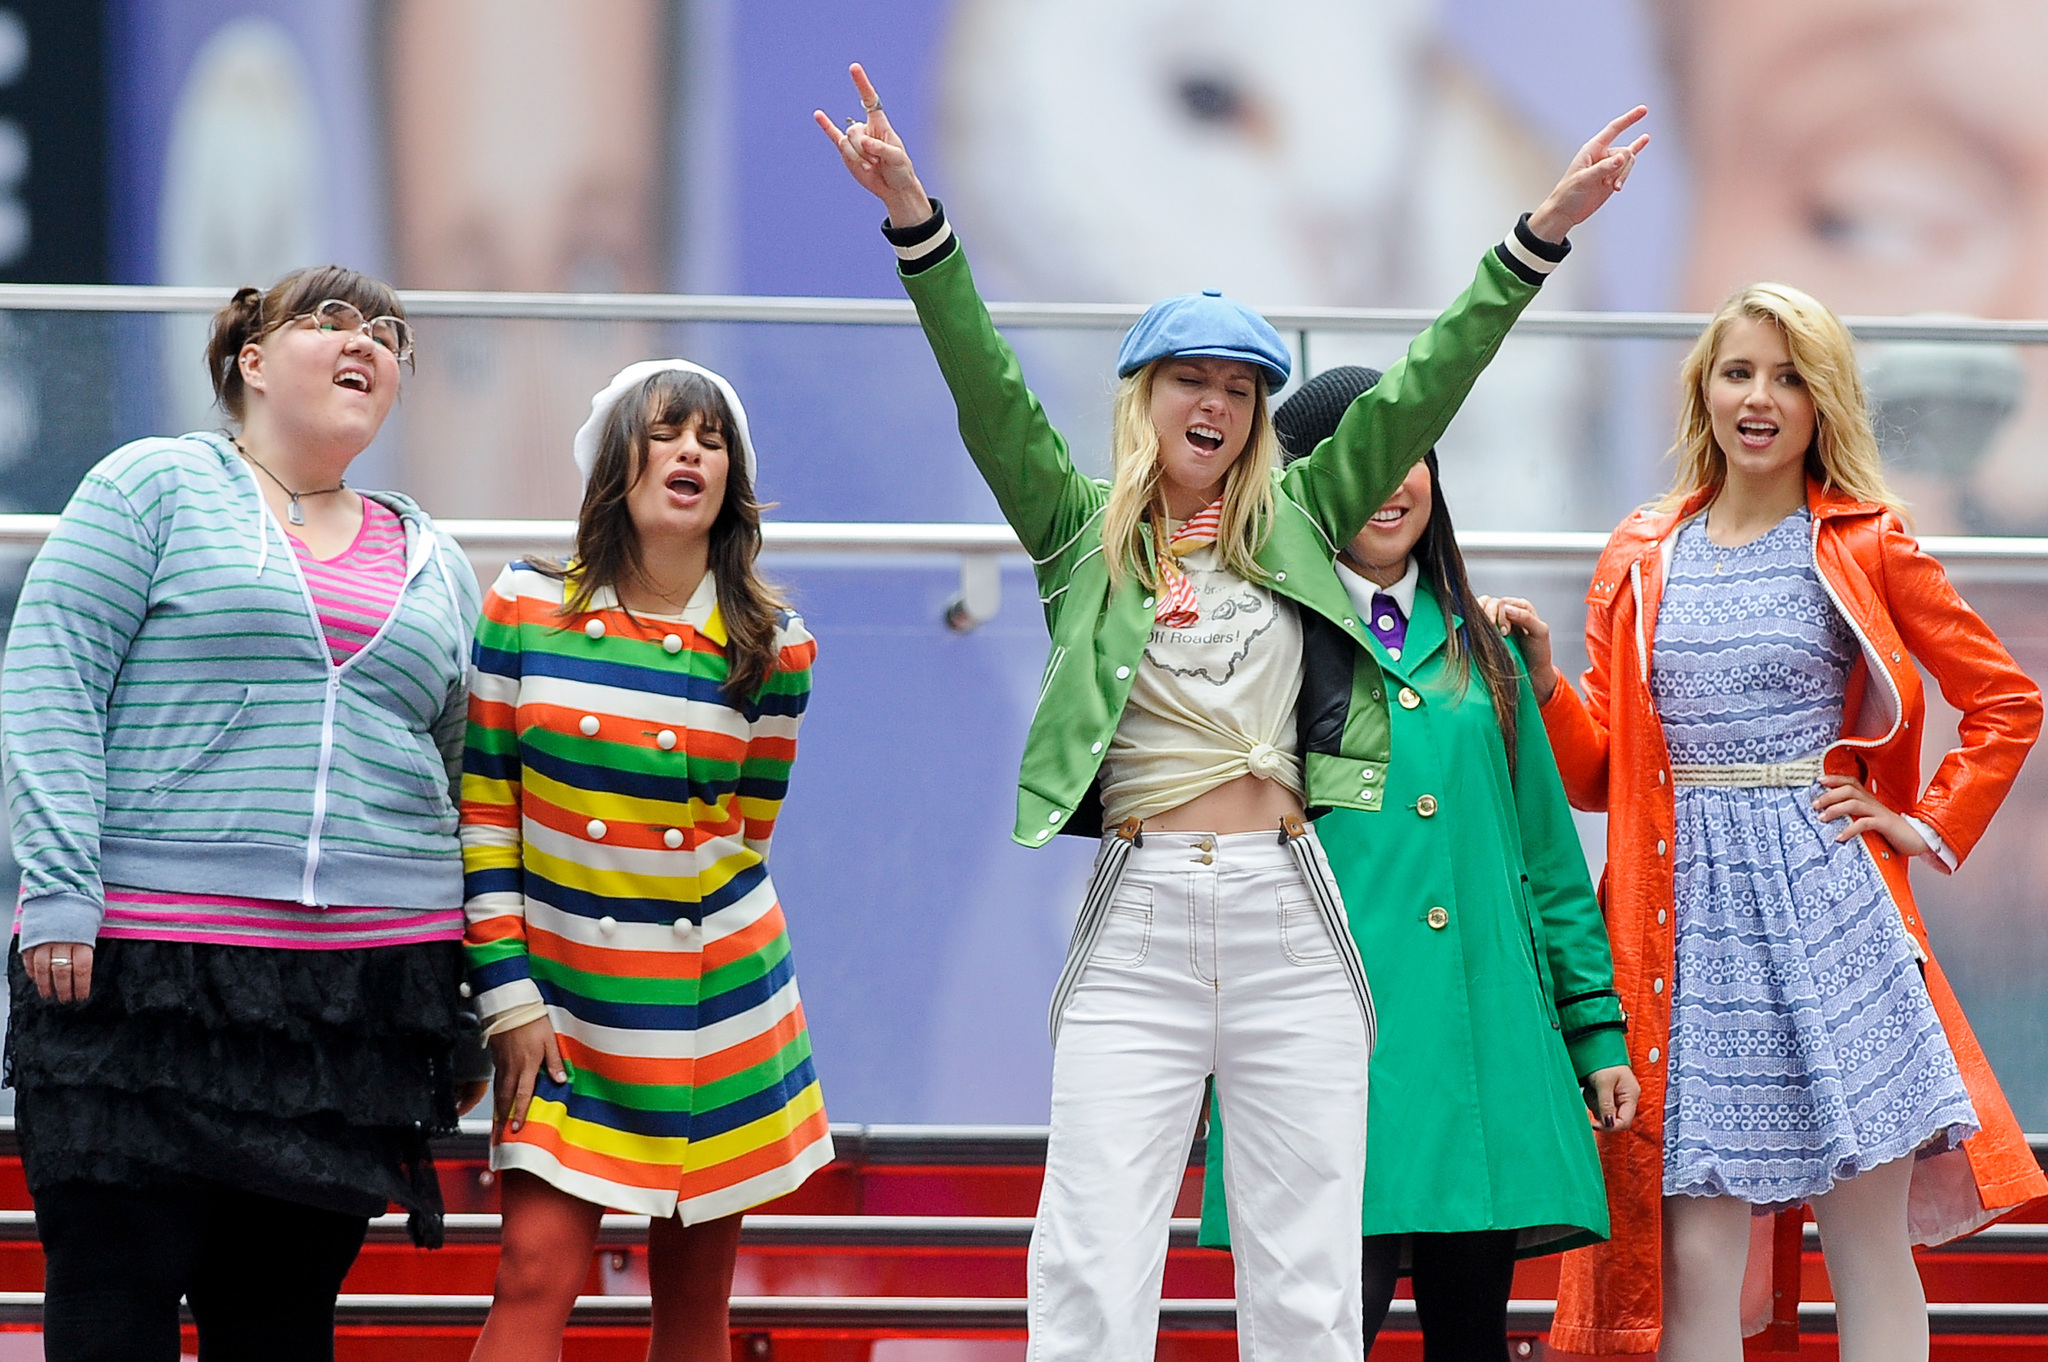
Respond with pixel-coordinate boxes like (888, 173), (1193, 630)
(813, 63), (1104, 559)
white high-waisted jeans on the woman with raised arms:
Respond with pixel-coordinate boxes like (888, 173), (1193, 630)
(1028, 832), (1370, 1362)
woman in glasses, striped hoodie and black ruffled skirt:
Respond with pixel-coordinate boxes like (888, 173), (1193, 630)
(0, 266), (477, 1362)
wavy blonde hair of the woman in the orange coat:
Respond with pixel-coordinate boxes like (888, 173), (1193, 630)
(1659, 285), (1905, 516)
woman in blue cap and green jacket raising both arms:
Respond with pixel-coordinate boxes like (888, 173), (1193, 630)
(815, 66), (1647, 1362)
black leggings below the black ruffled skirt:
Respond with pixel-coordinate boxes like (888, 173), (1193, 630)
(35, 1182), (369, 1362)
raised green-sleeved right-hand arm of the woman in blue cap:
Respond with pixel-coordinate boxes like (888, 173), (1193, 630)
(1288, 107), (1649, 545)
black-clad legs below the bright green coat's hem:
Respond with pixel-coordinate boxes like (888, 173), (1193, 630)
(1364, 1229), (1516, 1362)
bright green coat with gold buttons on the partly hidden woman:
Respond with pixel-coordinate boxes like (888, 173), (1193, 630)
(1202, 578), (1628, 1255)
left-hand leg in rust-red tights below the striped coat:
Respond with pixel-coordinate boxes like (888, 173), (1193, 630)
(469, 1167), (604, 1362)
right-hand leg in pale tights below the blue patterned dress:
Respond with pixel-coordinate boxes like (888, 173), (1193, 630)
(1812, 1155), (1927, 1362)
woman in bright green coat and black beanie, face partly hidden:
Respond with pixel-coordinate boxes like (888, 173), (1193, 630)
(1202, 369), (1638, 1362)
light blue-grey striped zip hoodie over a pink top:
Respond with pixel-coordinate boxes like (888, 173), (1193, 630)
(0, 432), (479, 948)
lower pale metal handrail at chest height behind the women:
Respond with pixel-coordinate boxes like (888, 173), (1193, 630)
(12, 514), (2048, 631)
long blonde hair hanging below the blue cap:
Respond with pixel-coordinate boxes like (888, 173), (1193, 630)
(1102, 356), (1280, 590)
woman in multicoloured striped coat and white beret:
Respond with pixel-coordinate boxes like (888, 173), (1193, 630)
(463, 360), (831, 1362)
